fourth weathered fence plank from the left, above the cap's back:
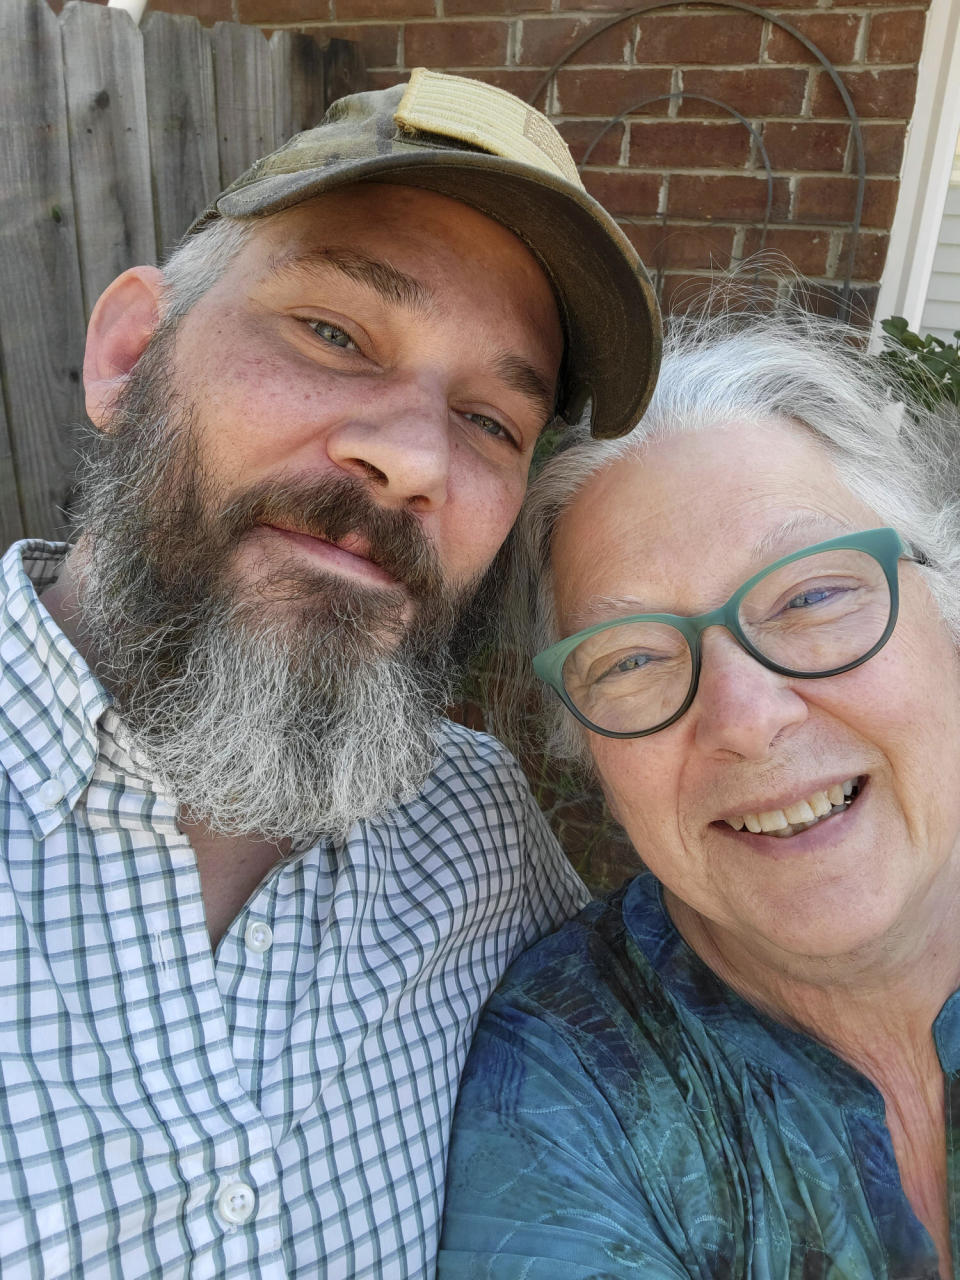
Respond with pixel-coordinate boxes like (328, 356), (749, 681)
(214, 22), (278, 188)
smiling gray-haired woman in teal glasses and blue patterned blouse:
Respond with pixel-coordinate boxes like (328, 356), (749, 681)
(439, 312), (960, 1280)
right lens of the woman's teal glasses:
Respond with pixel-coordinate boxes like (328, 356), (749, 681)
(739, 550), (891, 675)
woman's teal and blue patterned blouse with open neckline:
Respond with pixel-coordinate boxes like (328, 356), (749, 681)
(439, 876), (960, 1280)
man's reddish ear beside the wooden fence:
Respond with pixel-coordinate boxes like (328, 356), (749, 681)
(83, 266), (164, 431)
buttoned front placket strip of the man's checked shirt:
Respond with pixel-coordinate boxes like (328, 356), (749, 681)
(87, 762), (288, 1280)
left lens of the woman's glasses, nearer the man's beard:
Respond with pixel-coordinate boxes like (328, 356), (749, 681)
(563, 622), (692, 733)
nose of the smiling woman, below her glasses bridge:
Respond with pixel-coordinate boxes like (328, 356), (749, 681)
(691, 627), (808, 760)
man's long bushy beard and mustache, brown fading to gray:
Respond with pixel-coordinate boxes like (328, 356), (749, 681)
(78, 333), (471, 844)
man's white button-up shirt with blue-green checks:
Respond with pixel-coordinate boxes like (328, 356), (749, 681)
(0, 541), (584, 1280)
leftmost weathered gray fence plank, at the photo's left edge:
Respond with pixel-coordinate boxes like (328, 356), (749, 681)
(0, 0), (84, 536)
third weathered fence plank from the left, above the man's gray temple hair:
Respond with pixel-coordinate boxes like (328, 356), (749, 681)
(142, 13), (220, 257)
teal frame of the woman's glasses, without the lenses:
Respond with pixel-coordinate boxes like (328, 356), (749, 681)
(534, 529), (927, 737)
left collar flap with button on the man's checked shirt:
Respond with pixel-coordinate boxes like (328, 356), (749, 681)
(0, 539), (110, 840)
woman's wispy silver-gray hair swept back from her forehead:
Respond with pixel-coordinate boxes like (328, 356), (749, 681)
(494, 312), (960, 767)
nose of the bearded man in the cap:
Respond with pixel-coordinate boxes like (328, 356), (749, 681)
(326, 378), (451, 511)
